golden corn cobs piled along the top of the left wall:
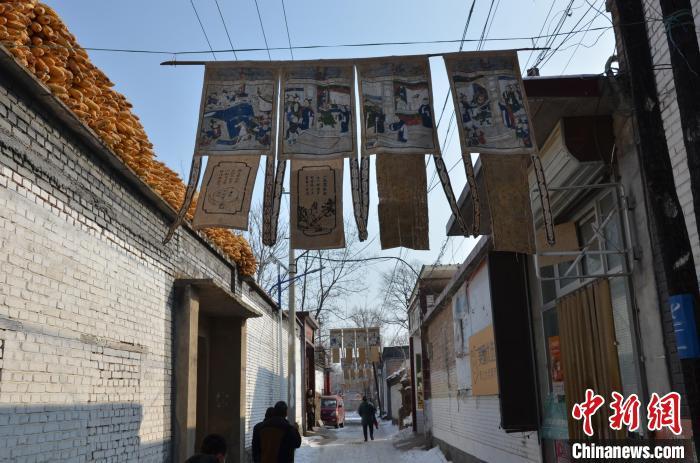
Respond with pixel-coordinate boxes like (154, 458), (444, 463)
(0, 0), (256, 275)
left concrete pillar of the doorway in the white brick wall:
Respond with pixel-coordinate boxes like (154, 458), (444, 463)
(173, 286), (199, 461)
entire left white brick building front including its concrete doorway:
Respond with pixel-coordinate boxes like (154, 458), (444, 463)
(0, 41), (296, 461)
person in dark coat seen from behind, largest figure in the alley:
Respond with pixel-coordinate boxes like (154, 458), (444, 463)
(253, 401), (301, 463)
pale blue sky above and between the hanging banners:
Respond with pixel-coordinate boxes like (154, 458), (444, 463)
(45, 0), (614, 334)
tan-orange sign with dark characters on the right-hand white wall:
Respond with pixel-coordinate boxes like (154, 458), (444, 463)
(469, 325), (498, 395)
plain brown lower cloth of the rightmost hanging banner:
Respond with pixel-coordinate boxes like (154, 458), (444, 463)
(481, 154), (535, 254)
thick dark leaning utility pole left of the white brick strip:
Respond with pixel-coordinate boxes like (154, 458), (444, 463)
(612, 0), (700, 452)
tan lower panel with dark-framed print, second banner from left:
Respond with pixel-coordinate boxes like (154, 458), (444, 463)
(290, 159), (345, 249)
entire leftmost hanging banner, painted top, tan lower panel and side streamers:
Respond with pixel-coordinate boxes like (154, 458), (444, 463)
(166, 63), (279, 242)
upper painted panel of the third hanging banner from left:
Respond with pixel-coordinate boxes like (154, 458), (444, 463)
(357, 56), (440, 155)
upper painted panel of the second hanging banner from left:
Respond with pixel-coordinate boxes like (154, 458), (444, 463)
(281, 62), (355, 159)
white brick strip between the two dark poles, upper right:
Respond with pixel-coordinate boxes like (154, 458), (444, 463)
(644, 0), (700, 282)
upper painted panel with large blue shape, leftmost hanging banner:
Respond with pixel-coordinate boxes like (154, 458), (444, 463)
(195, 63), (279, 155)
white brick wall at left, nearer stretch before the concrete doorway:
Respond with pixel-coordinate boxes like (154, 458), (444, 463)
(0, 63), (259, 462)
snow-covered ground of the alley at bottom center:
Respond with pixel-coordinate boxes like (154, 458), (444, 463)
(294, 422), (448, 463)
